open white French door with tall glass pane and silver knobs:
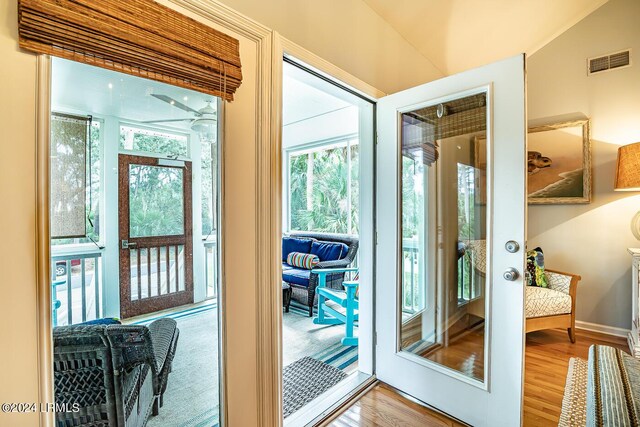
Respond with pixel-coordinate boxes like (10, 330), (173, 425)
(375, 55), (526, 426)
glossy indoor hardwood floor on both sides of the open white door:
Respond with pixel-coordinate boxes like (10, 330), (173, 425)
(328, 329), (628, 427)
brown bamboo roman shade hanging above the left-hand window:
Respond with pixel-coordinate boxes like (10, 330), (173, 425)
(18, 0), (242, 101)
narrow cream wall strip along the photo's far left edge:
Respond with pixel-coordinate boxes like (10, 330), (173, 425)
(0, 1), (38, 426)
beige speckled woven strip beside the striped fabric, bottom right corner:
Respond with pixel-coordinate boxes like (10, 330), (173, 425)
(558, 357), (589, 427)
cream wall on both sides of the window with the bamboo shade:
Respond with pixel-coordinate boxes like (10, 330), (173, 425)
(0, 1), (260, 427)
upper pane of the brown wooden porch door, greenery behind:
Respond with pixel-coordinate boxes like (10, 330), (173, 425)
(129, 165), (184, 237)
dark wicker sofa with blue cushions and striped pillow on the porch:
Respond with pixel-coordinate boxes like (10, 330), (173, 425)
(282, 232), (358, 317)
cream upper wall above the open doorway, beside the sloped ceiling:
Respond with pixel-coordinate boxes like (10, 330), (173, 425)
(221, 0), (443, 93)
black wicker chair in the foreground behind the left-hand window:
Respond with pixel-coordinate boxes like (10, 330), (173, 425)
(53, 319), (179, 427)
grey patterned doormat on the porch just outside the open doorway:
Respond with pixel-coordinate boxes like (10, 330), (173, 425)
(282, 356), (347, 418)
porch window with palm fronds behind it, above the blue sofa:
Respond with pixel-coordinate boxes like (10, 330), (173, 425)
(288, 139), (359, 234)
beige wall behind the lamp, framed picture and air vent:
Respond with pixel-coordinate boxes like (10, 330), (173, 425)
(528, 0), (640, 329)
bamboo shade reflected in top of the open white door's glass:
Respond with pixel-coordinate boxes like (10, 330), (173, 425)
(402, 93), (487, 166)
